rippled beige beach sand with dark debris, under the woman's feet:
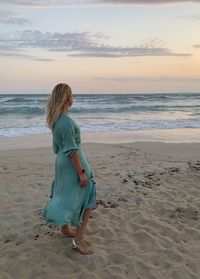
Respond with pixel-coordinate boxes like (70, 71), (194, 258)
(0, 136), (200, 279)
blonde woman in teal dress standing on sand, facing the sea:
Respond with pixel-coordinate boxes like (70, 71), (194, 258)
(42, 83), (96, 255)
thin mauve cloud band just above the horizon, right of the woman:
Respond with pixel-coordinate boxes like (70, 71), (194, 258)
(94, 76), (200, 82)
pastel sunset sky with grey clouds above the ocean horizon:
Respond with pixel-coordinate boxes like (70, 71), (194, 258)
(0, 0), (200, 94)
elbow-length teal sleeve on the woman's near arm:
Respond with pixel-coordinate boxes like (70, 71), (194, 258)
(61, 122), (79, 157)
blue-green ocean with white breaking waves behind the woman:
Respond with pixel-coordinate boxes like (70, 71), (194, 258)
(0, 93), (200, 137)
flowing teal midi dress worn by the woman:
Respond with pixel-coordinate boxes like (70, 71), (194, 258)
(42, 112), (96, 227)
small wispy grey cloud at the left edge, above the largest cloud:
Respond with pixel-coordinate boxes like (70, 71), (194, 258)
(0, 10), (32, 26)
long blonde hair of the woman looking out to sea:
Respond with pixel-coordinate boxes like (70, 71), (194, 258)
(46, 83), (72, 129)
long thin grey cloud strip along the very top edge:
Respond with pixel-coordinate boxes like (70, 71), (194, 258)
(0, 0), (200, 8)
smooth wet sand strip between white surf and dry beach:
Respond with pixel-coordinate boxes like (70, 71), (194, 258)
(0, 128), (200, 151)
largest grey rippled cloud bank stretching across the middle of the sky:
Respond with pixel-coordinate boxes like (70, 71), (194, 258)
(0, 30), (191, 57)
